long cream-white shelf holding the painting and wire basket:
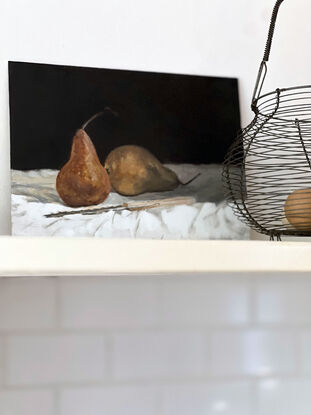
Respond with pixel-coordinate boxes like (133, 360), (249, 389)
(0, 236), (311, 277)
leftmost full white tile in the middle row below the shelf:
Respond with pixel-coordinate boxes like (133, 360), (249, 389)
(6, 334), (106, 386)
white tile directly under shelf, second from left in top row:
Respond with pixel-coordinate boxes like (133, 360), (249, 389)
(60, 278), (158, 328)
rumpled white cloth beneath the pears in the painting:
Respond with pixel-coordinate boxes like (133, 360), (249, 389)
(12, 165), (249, 239)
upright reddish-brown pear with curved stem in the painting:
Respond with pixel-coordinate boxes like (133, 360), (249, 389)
(56, 129), (110, 207)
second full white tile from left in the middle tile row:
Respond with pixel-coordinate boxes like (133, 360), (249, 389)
(112, 330), (208, 380)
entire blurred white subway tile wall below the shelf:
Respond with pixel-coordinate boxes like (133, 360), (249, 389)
(0, 274), (311, 415)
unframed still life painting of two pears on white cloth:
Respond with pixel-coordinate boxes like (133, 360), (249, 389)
(9, 62), (249, 239)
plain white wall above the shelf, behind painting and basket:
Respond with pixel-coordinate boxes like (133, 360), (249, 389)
(0, 0), (311, 234)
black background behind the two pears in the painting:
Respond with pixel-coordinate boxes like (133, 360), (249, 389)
(9, 62), (240, 170)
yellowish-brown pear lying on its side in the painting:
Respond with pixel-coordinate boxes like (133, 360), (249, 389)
(105, 145), (180, 196)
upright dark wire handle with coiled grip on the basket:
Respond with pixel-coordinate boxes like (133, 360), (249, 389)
(251, 0), (284, 113)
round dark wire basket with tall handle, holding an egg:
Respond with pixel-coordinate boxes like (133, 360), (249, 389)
(223, 0), (311, 240)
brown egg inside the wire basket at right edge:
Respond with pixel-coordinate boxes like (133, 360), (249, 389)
(284, 189), (311, 231)
